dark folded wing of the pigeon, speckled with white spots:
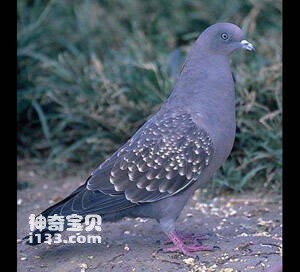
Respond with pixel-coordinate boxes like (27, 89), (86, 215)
(87, 110), (213, 203)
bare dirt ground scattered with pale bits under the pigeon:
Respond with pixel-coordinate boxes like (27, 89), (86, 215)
(17, 163), (282, 272)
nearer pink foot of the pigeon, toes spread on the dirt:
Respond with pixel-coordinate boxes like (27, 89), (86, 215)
(163, 231), (215, 256)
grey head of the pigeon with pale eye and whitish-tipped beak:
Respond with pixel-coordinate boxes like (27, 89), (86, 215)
(199, 23), (255, 55)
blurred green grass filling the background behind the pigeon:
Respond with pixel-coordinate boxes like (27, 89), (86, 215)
(17, 0), (282, 192)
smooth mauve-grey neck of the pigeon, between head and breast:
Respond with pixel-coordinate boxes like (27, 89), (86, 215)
(167, 47), (235, 111)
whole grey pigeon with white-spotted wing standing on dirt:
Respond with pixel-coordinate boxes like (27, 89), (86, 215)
(25, 23), (254, 255)
